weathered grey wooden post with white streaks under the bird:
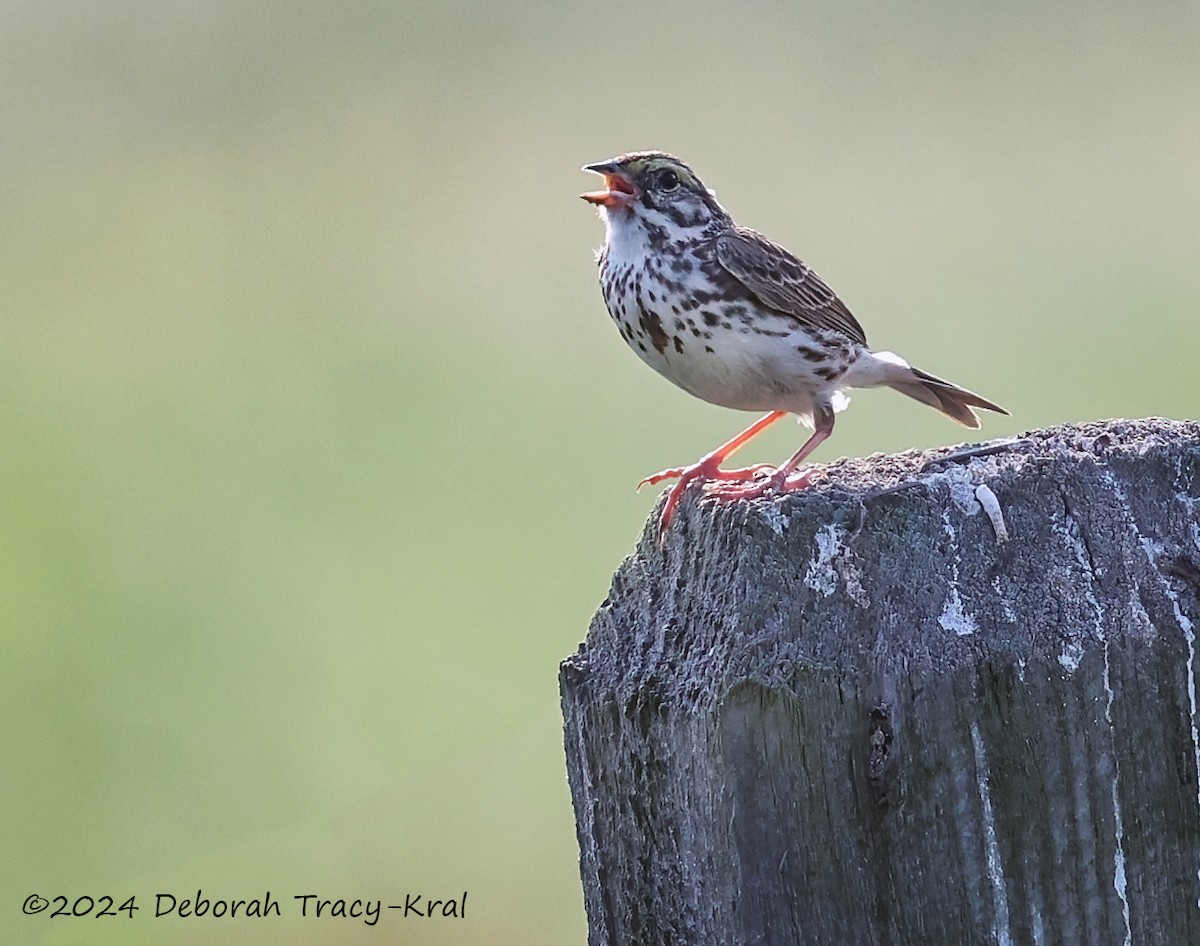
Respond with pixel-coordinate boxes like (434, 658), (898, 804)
(560, 419), (1200, 946)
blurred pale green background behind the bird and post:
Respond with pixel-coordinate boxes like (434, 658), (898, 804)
(0, 0), (1200, 946)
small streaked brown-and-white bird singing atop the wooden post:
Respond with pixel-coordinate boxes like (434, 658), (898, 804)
(581, 151), (1008, 538)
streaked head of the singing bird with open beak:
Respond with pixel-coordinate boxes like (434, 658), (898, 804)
(580, 151), (727, 229)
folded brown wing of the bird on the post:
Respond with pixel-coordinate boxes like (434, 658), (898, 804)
(716, 227), (866, 345)
